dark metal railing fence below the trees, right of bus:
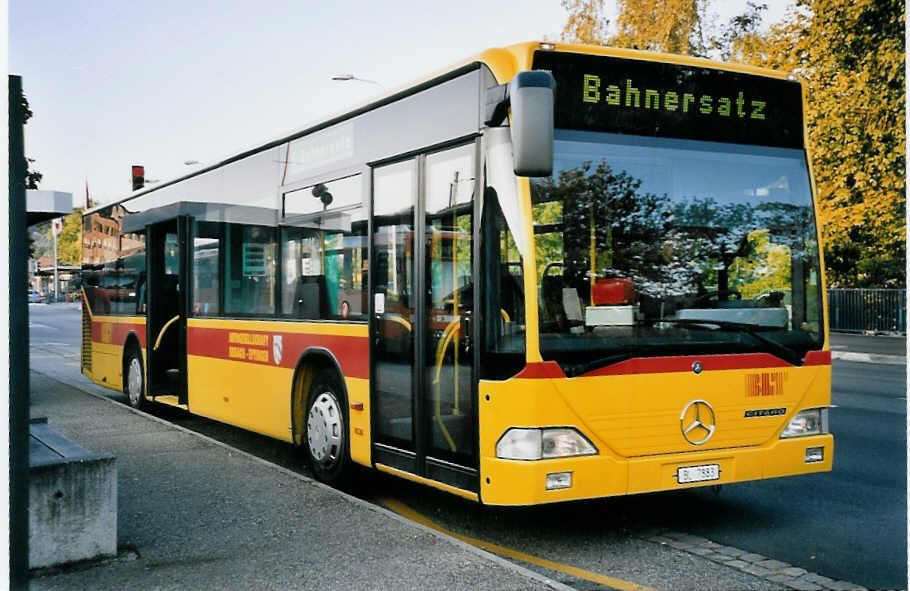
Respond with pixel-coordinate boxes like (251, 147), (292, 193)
(828, 289), (907, 334)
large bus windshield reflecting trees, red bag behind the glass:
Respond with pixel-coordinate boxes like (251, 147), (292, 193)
(531, 130), (823, 375)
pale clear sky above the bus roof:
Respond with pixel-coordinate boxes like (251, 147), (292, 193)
(8, 0), (791, 213)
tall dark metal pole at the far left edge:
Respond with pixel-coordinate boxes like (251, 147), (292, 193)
(8, 76), (29, 590)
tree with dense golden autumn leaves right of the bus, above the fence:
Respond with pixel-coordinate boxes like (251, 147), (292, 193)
(732, 0), (906, 287)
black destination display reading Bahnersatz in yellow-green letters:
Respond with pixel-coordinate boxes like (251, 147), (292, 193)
(533, 51), (803, 148)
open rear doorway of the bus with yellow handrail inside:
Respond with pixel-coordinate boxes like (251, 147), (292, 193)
(146, 216), (190, 404)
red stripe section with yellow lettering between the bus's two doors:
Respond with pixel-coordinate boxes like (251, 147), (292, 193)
(187, 326), (370, 379)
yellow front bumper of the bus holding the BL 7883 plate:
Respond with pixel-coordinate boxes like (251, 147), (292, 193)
(480, 434), (834, 505)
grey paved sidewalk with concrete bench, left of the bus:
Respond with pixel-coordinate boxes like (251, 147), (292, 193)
(31, 372), (567, 591)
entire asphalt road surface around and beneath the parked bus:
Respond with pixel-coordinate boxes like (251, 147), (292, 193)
(30, 304), (907, 589)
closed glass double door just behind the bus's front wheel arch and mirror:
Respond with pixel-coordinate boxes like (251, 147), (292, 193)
(371, 143), (479, 492)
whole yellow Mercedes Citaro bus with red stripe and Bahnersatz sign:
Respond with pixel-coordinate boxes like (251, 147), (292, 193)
(82, 42), (834, 505)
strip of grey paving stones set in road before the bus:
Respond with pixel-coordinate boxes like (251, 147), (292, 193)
(638, 531), (868, 591)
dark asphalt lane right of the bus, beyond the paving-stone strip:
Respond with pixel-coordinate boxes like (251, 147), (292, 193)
(665, 361), (907, 589)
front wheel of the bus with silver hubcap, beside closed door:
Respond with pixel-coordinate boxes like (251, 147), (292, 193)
(303, 369), (351, 487)
